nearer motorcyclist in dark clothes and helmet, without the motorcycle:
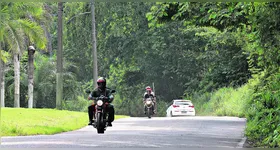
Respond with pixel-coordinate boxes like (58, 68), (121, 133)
(88, 77), (115, 127)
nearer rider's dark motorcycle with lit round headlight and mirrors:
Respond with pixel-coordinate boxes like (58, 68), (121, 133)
(86, 90), (116, 134)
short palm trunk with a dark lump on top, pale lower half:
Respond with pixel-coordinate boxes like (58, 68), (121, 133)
(28, 50), (35, 108)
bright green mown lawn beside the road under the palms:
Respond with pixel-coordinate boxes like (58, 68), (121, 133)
(1, 108), (128, 136)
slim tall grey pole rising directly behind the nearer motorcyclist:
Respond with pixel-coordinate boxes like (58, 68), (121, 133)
(91, 0), (98, 88)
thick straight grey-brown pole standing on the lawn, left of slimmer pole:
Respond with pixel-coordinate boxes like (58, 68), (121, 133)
(56, 2), (63, 109)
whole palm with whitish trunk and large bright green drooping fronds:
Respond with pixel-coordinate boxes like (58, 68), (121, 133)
(0, 2), (46, 107)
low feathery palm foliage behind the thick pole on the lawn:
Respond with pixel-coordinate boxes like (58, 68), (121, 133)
(34, 55), (82, 108)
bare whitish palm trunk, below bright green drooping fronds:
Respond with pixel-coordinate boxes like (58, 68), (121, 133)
(14, 54), (20, 108)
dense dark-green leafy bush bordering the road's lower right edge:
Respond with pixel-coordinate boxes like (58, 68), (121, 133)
(245, 71), (280, 148)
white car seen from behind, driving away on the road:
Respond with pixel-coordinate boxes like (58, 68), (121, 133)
(166, 99), (195, 117)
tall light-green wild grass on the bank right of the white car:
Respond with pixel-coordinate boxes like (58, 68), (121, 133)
(194, 84), (253, 117)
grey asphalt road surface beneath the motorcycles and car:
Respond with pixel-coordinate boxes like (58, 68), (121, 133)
(1, 116), (246, 148)
